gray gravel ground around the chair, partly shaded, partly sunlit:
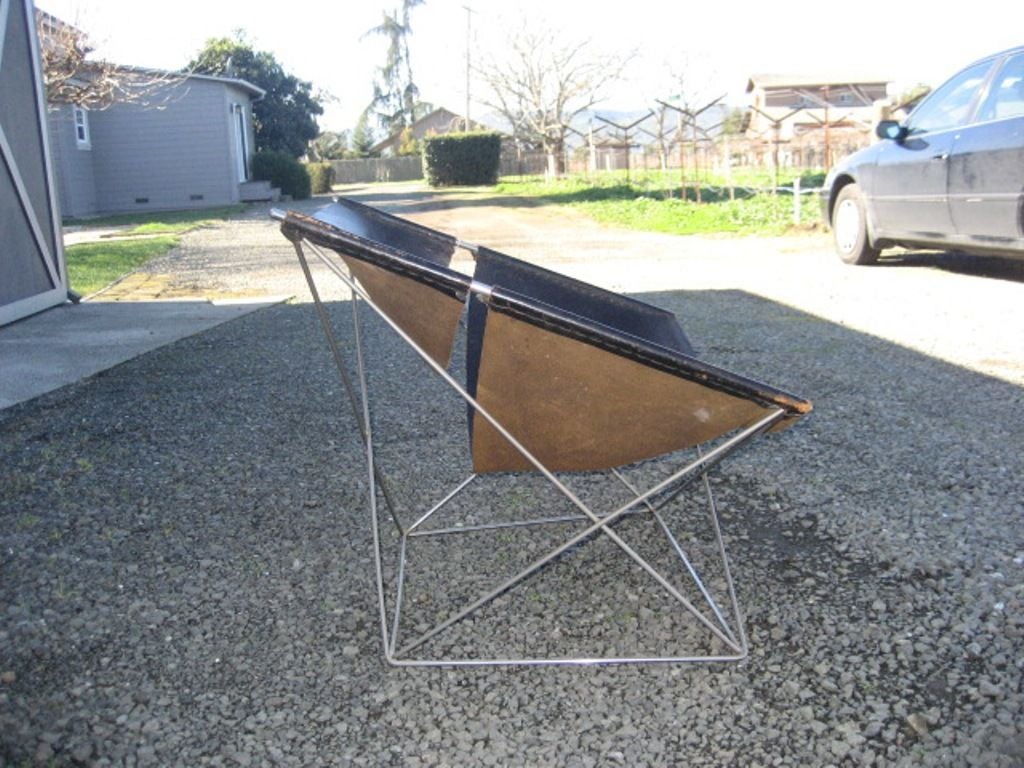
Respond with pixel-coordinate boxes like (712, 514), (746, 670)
(0, 187), (1024, 766)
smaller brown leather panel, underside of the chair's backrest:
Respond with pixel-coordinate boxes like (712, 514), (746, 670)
(341, 254), (464, 368)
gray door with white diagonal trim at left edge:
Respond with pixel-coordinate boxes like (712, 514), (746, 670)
(0, 0), (68, 325)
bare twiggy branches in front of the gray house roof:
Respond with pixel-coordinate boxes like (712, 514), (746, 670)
(36, 11), (185, 110)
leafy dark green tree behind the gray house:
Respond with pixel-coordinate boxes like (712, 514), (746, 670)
(188, 32), (324, 158)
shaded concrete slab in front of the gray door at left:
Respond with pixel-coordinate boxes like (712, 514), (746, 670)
(0, 296), (289, 409)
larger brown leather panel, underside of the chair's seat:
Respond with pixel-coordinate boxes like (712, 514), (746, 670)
(473, 311), (767, 473)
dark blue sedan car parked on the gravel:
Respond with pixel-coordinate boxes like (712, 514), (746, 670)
(821, 46), (1024, 264)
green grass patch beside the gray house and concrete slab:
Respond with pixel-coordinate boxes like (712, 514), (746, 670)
(65, 206), (245, 296)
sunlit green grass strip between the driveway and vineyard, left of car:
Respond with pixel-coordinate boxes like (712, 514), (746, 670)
(496, 171), (821, 234)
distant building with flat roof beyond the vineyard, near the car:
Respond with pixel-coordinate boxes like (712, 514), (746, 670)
(746, 75), (892, 141)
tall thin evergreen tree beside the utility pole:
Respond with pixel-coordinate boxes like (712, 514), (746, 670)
(364, 0), (425, 134)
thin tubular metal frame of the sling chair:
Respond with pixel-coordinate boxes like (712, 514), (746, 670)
(292, 238), (786, 667)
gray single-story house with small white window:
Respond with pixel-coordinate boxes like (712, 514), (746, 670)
(49, 68), (269, 217)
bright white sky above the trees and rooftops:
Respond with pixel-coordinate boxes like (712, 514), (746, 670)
(37, 0), (1024, 130)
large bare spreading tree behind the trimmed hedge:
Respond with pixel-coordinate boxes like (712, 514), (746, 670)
(476, 26), (632, 174)
